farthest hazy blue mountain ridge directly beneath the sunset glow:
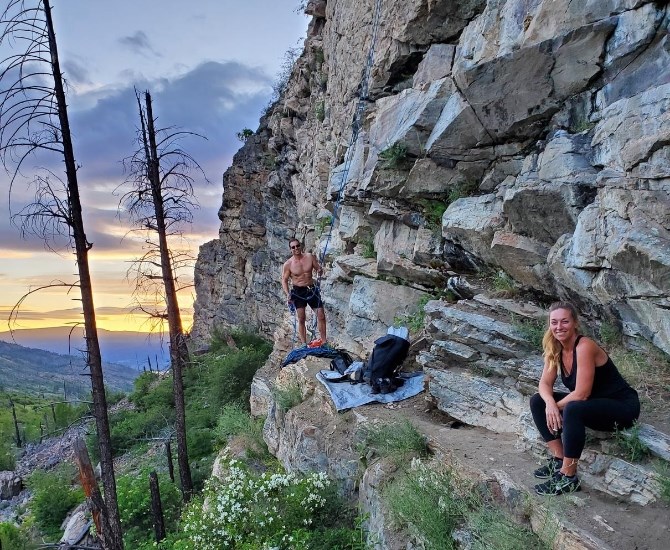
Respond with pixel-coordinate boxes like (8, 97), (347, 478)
(0, 327), (170, 371)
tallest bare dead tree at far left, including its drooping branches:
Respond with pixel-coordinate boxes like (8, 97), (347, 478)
(0, 0), (123, 550)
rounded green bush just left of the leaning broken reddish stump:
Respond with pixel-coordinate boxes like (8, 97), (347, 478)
(27, 465), (84, 539)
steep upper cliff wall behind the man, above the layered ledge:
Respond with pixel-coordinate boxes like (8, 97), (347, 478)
(194, 0), (670, 354)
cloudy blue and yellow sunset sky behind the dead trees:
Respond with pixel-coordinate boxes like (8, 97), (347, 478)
(0, 0), (308, 331)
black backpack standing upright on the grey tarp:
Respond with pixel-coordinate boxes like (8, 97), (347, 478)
(363, 334), (409, 393)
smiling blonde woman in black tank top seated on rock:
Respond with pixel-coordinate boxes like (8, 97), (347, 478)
(530, 302), (640, 495)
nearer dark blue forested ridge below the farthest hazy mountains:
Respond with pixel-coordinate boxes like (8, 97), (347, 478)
(0, 342), (138, 398)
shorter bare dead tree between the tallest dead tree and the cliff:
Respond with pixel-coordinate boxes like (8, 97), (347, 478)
(120, 91), (206, 501)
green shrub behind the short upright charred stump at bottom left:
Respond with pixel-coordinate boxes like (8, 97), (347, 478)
(116, 471), (181, 548)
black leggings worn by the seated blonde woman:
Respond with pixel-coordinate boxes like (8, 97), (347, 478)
(530, 392), (640, 458)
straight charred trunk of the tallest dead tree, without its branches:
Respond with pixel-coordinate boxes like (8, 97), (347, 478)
(43, 0), (123, 550)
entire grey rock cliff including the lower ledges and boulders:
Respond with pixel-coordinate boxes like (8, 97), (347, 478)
(193, 0), (670, 548)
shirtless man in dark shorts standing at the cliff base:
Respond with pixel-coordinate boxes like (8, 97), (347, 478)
(281, 239), (326, 347)
